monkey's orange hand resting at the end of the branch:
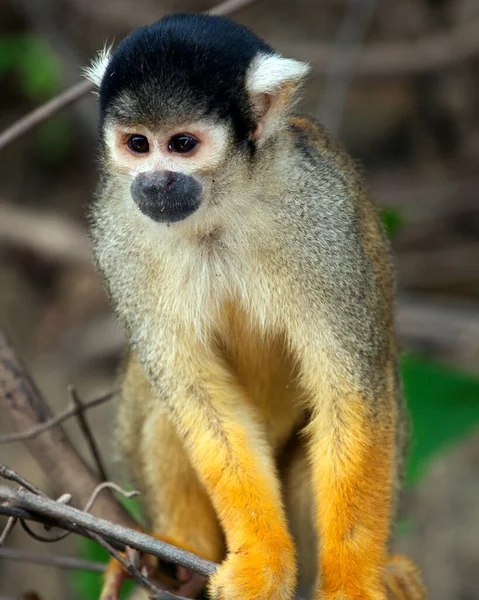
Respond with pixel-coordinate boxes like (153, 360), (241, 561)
(208, 540), (296, 600)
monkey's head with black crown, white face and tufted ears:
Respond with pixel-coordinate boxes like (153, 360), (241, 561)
(87, 15), (308, 223)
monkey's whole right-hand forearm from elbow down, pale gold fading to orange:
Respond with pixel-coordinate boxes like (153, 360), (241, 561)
(303, 355), (397, 600)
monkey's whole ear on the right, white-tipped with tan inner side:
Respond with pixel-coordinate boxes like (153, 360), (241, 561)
(246, 54), (309, 142)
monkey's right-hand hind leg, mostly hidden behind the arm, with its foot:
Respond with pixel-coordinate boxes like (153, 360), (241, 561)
(280, 436), (426, 600)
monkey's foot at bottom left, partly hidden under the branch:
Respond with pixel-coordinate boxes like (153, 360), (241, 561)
(100, 536), (206, 600)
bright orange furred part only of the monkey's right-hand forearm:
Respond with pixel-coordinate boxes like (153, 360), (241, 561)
(311, 397), (394, 600)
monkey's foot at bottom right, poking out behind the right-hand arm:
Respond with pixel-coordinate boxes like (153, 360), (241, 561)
(384, 554), (427, 600)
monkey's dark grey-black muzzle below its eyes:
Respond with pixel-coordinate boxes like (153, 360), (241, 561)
(130, 171), (203, 223)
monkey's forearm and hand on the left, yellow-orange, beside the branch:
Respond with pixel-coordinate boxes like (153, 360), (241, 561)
(141, 332), (296, 600)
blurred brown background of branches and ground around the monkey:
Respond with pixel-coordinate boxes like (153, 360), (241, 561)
(0, 0), (479, 600)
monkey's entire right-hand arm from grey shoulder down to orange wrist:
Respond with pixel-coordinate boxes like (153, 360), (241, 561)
(282, 119), (402, 600)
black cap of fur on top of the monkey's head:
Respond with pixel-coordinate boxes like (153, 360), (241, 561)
(100, 14), (273, 141)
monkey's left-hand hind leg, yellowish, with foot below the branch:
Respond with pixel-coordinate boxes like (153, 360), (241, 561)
(101, 357), (224, 600)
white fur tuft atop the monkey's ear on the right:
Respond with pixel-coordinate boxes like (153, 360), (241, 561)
(246, 54), (309, 94)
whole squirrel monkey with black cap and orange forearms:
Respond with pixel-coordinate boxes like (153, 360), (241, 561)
(87, 15), (424, 600)
